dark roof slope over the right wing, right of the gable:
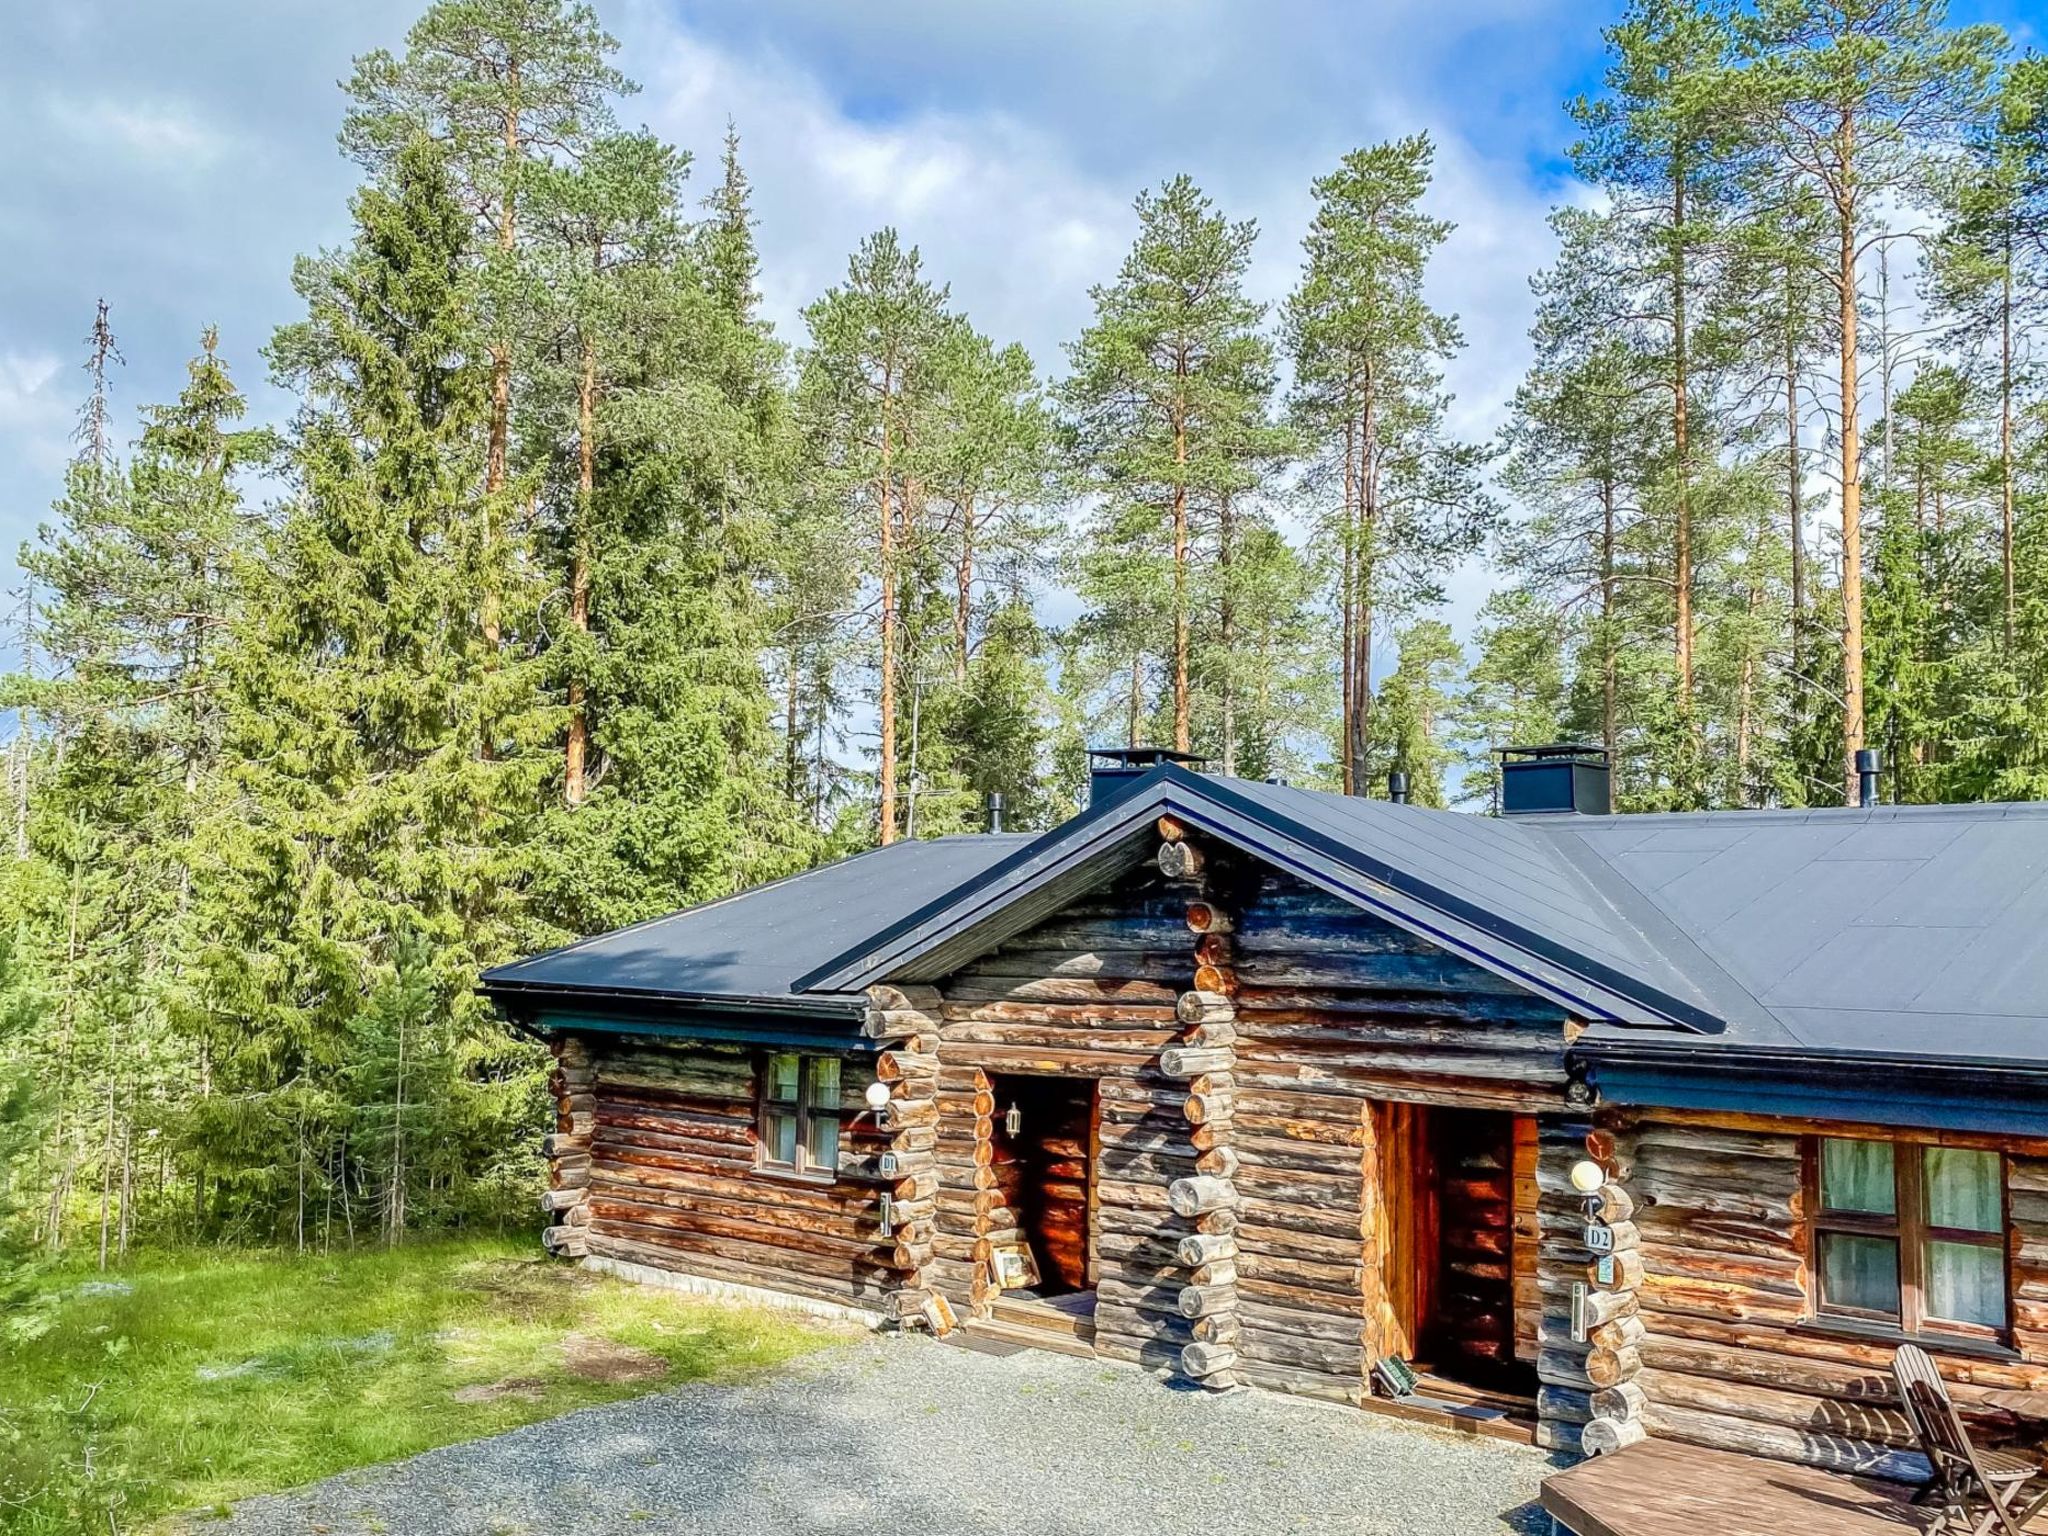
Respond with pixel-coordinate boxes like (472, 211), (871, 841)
(1522, 805), (2048, 1061)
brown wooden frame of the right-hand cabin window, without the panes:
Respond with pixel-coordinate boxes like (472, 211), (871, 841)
(1800, 1133), (2013, 1346)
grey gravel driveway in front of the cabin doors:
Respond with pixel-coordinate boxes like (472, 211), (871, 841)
(188, 1337), (1548, 1536)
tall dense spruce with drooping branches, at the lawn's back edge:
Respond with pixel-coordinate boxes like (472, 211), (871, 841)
(195, 135), (555, 1235)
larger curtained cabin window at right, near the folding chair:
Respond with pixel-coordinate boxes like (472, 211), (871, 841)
(1808, 1137), (2007, 1337)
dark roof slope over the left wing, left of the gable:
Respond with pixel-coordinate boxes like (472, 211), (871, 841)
(481, 834), (1030, 1014)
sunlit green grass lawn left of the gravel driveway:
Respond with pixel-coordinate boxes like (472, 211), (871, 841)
(0, 1241), (840, 1536)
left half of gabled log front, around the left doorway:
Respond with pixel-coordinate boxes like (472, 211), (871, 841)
(928, 843), (1235, 1386)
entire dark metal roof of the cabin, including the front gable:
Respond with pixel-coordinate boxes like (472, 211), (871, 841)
(483, 764), (2048, 1092)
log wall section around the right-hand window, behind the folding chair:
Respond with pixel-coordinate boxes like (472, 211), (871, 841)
(1622, 1116), (2048, 1479)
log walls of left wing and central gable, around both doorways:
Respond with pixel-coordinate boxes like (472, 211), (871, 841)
(557, 856), (1587, 1419)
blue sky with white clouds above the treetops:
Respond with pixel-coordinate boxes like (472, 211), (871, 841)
(0, 0), (2044, 659)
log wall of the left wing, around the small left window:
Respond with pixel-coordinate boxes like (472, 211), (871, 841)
(549, 1034), (915, 1307)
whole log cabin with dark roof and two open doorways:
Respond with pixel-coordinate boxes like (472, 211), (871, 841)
(483, 748), (2048, 1479)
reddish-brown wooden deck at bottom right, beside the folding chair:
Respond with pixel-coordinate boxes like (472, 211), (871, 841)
(1542, 1440), (1949, 1536)
